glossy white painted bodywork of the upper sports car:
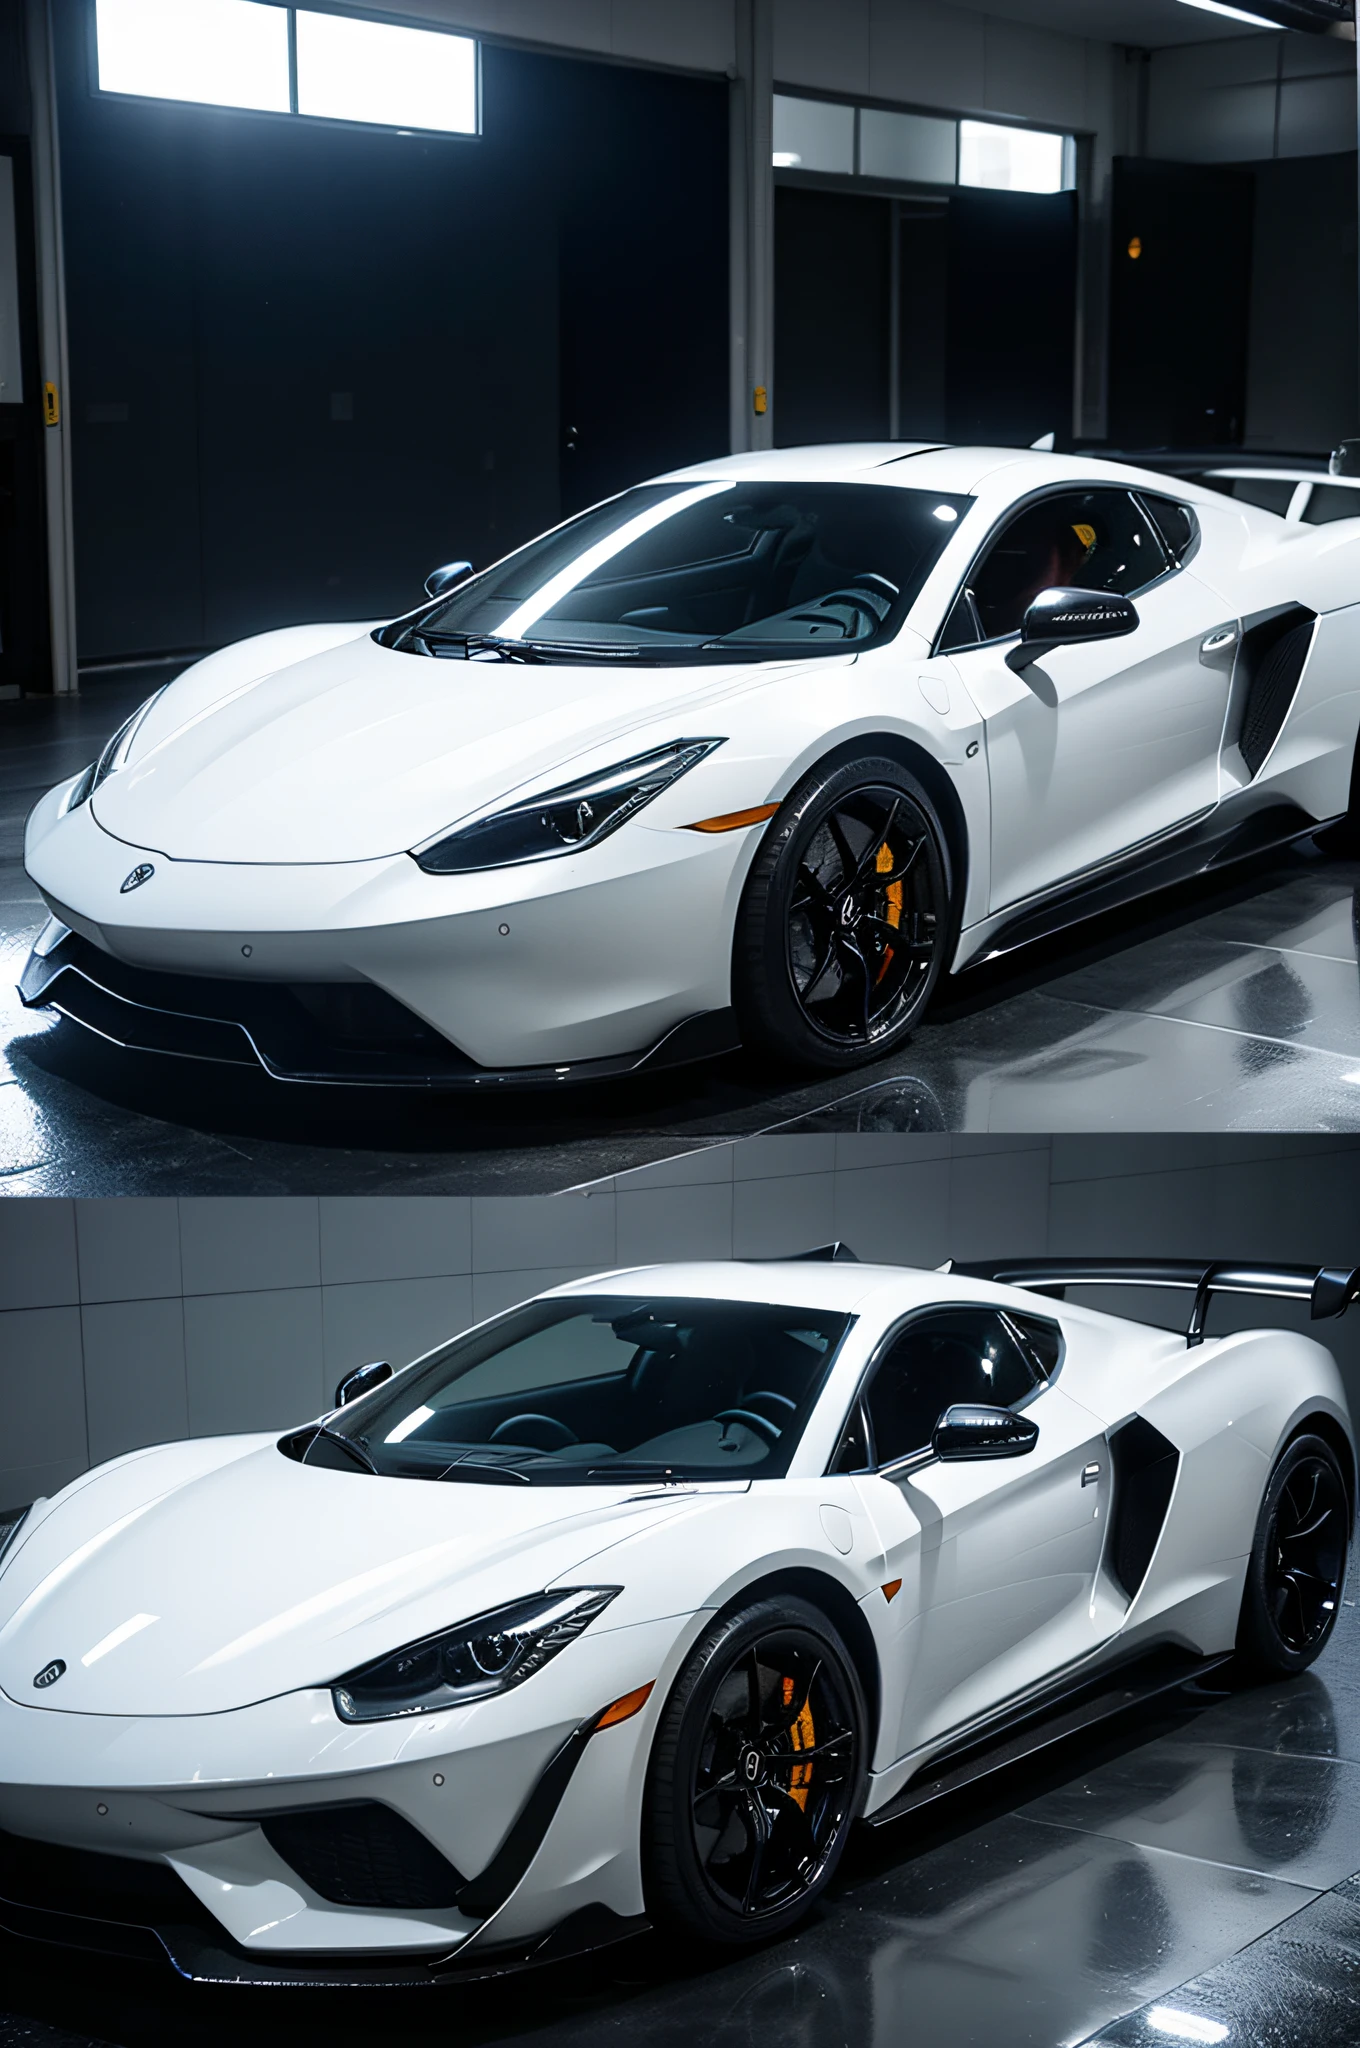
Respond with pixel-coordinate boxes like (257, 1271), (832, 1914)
(25, 442), (1360, 1067)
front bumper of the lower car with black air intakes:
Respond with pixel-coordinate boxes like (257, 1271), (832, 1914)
(0, 1622), (676, 1982)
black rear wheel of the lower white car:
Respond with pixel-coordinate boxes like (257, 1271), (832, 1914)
(1237, 1436), (1350, 1677)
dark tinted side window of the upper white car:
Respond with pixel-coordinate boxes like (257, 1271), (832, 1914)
(969, 492), (1172, 639)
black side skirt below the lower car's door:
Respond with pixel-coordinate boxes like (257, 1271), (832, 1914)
(866, 1649), (1229, 1827)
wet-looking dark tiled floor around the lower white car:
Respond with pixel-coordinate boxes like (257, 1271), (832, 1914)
(0, 1583), (1360, 2048)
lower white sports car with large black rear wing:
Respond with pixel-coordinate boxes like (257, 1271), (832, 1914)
(0, 1247), (1360, 1982)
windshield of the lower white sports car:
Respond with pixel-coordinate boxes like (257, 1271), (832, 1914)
(305, 1294), (850, 1487)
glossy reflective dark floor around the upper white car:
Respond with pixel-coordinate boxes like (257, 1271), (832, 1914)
(0, 672), (1360, 1194)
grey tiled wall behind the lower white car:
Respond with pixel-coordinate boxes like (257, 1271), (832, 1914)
(0, 1135), (1360, 1507)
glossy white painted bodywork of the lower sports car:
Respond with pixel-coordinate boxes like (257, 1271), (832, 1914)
(0, 1262), (1350, 1954)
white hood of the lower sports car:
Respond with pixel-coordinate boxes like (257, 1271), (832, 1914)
(0, 1438), (682, 1714)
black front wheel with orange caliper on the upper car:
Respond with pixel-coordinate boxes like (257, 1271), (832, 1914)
(731, 754), (954, 1071)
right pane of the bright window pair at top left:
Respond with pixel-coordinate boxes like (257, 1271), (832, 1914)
(297, 8), (477, 135)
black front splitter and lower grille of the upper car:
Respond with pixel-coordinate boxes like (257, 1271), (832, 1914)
(18, 932), (739, 1090)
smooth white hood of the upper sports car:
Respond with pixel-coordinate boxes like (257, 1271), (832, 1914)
(92, 635), (798, 864)
